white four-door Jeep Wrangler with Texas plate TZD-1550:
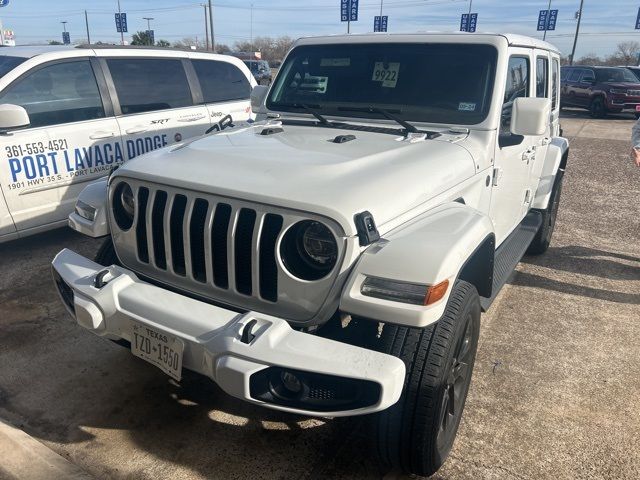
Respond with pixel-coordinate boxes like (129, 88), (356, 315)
(53, 34), (568, 475)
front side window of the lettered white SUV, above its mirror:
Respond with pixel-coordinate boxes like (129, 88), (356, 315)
(0, 60), (105, 128)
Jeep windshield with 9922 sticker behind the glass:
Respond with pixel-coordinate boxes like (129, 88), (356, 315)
(267, 43), (497, 125)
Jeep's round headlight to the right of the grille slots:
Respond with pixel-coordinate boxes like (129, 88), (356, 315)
(280, 220), (338, 280)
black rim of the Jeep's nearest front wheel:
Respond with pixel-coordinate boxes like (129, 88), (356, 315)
(436, 314), (473, 448)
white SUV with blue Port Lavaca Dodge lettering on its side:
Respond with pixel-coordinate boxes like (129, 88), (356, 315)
(0, 46), (255, 242)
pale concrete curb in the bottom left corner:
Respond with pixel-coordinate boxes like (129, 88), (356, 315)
(0, 419), (93, 480)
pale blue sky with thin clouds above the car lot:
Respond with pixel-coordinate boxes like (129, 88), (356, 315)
(0, 0), (640, 57)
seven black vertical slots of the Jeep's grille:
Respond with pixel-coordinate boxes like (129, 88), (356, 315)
(135, 187), (283, 302)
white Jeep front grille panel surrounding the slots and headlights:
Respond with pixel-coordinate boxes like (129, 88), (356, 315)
(109, 178), (347, 322)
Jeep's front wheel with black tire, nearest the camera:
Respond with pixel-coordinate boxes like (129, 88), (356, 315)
(369, 281), (480, 475)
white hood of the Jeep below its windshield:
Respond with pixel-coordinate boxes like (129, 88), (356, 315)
(113, 123), (476, 236)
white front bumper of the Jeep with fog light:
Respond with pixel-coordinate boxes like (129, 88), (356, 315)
(52, 249), (405, 417)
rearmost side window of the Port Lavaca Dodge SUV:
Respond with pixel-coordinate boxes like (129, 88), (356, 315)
(191, 60), (251, 103)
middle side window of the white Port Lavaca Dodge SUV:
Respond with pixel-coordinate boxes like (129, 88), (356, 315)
(107, 57), (193, 114)
